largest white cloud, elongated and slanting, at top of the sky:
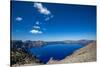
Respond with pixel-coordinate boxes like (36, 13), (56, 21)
(34, 3), (51, 15)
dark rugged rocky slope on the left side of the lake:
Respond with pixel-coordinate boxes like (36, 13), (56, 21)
(10, 40), (43, 67)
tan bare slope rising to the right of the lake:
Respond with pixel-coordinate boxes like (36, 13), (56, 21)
(47, 42), (96, 64)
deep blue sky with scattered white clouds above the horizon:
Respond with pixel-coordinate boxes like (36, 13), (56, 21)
(11, 1), (96, 41)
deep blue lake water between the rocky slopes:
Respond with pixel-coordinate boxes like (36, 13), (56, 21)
(29, 44), (83, 63)
